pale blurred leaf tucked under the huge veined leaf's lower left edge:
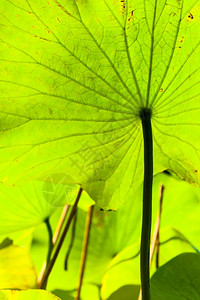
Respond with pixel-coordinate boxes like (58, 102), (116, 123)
(0, 181), (93, 235)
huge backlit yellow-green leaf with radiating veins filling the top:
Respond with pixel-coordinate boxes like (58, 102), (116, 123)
(0, 0), (200, 208)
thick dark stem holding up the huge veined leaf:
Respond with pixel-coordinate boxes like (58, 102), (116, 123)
(140, 108), (153, 300)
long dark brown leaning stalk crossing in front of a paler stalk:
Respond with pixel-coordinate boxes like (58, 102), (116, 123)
(40, 188), (83, 289)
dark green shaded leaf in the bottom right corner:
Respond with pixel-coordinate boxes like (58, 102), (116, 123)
(151, 253), (200, 300)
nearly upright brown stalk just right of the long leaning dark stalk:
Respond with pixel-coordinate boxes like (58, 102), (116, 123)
(75, 206), (93, 300)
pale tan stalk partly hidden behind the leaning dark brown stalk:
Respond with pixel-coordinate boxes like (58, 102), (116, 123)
(37, 205), (69, 288)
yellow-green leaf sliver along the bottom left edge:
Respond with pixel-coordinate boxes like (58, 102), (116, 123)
(0, 290), (60, 300)
